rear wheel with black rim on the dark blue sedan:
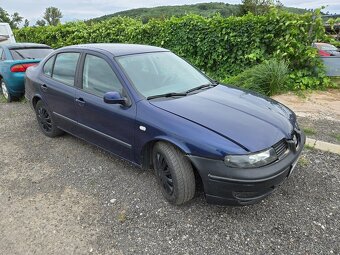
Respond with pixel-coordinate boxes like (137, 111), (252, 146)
(35, 100), (64, 138)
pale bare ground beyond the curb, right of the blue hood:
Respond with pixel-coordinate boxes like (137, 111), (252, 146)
(298, 117), (340, 144)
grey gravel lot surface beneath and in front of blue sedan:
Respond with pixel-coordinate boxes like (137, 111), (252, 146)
(0, 103), (340, 254)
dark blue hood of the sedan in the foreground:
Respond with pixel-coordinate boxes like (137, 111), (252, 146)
(150, 85), (296, 152)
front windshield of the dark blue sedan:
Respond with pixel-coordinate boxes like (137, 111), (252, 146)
(116, 52), (211, 98)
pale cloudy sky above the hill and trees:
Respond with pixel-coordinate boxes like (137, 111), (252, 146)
(0, 0), (340, 24)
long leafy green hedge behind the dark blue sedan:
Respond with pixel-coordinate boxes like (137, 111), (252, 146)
(15, 9), (327, 92)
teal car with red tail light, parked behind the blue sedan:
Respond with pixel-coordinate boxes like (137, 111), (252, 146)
(0, 43), (53, 102)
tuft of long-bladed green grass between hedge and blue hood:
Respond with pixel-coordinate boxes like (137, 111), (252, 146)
(225, 59), (289, 96)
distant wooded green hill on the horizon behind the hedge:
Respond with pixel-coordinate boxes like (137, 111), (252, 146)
(90, 3), (308, 22)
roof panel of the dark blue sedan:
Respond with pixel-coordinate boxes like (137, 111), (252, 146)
(63, 43), (169, 57)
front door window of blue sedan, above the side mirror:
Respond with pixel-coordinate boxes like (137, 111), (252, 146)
(83, 54), (122, 97)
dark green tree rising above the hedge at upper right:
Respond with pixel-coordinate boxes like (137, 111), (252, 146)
(241, 0), (283, 15)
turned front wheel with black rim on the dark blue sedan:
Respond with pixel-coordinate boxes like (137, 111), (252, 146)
(152, 142), (196, 205)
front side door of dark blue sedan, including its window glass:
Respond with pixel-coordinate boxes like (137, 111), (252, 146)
(76, 53), (136, 161)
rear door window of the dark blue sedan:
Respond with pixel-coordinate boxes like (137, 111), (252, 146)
(52, 52), (80, 86)
